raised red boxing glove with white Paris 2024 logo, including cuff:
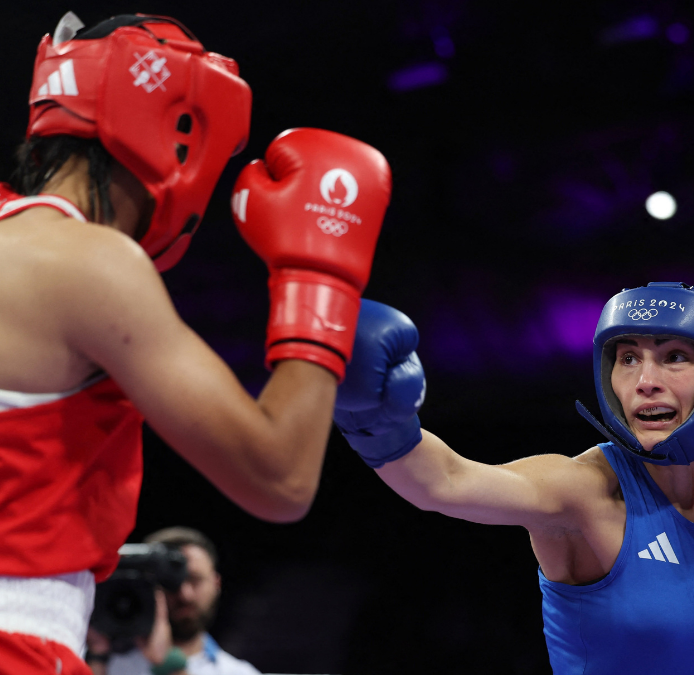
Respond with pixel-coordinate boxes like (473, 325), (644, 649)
(231, 129), (391, 381)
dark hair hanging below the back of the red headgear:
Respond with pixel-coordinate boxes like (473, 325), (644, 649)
(10, 134), (114, 223)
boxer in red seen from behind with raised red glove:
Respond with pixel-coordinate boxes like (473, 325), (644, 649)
(0, 14), (390, 675)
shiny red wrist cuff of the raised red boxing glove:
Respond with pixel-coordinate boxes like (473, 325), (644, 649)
(265, 268), (360, 381)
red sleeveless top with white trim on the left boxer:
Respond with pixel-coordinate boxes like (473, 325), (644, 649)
(0, 185), (142, 582)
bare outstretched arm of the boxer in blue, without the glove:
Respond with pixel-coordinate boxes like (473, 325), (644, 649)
(377, 431), (610, 530)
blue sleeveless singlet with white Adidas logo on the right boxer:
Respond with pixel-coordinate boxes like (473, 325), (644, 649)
(539, 443), (694, 675)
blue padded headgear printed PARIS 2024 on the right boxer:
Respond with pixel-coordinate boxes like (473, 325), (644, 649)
(576, 282), (694, 465)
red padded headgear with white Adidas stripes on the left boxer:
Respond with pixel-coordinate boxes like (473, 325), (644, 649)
(27, 15), (251, 271)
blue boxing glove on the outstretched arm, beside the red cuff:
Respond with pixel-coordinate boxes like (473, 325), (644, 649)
(334, 300), (426, 469)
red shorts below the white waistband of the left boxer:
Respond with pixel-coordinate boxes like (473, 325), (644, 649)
(0, 632), (92, 675)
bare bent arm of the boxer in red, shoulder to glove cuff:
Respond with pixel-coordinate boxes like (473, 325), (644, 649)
(62, 231), (337, 521)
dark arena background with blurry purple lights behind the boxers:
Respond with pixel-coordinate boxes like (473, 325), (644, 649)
(0, 0), (694, 675)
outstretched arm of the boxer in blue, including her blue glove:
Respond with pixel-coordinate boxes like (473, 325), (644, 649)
(335, 300), (615, 530)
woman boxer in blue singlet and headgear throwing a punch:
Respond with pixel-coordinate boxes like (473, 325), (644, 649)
(335, 283), (694, 675)
